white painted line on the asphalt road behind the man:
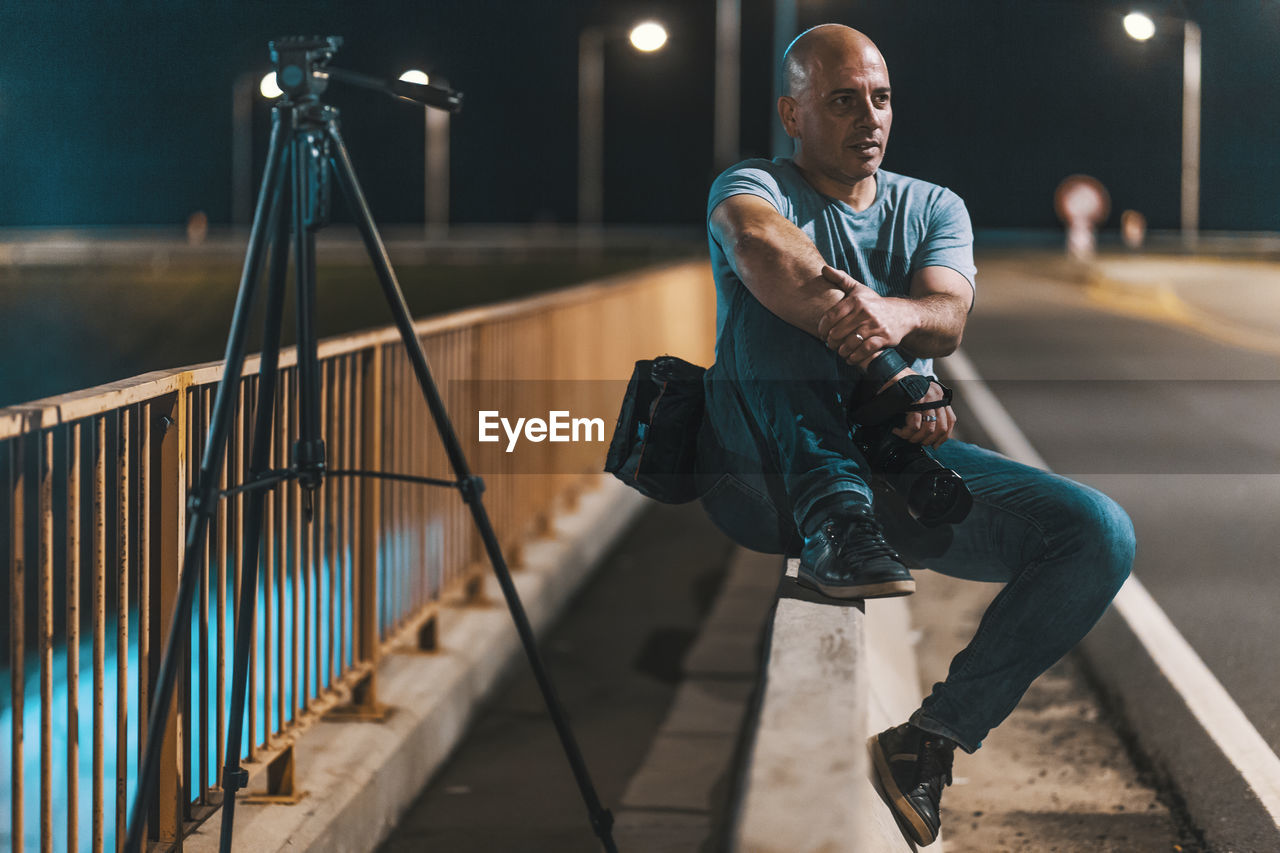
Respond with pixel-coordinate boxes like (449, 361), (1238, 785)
(946, 351), (1280, 827)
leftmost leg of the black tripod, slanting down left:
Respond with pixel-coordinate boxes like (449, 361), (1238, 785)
(124, 106), (293, 852)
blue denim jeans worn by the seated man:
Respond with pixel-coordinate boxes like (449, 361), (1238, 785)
(699, 281), (1134, 752)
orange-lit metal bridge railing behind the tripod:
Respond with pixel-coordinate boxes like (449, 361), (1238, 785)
(0, 263), (716, 853)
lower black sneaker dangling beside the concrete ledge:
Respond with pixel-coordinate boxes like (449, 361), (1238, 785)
(869, 722), (955, 847)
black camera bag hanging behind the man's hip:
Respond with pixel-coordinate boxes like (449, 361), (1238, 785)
(604, 355), (707, 503)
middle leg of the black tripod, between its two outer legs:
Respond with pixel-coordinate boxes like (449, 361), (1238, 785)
(219, 142), (298, 853)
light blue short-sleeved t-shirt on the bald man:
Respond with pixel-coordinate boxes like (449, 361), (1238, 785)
(707, 158), (977, 374)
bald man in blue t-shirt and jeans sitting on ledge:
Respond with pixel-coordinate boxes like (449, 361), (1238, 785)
(699, 24), (1134, 844)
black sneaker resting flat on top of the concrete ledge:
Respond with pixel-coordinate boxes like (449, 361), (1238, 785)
(796, 506), (915, 598)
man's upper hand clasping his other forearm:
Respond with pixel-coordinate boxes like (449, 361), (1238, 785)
(818, 266), (918, 368)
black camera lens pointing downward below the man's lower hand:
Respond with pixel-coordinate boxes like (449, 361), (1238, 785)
(854, 427), (973, 528)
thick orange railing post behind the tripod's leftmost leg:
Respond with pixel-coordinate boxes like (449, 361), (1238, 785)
(147, 388), (191, 849)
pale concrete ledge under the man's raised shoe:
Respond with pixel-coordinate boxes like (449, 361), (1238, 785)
(733, 560), (940, 853)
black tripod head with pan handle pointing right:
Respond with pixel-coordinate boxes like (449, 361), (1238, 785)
(269, 36), (462, 113)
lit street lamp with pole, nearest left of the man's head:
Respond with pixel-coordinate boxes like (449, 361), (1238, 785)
(577, 20), (667, 225)
